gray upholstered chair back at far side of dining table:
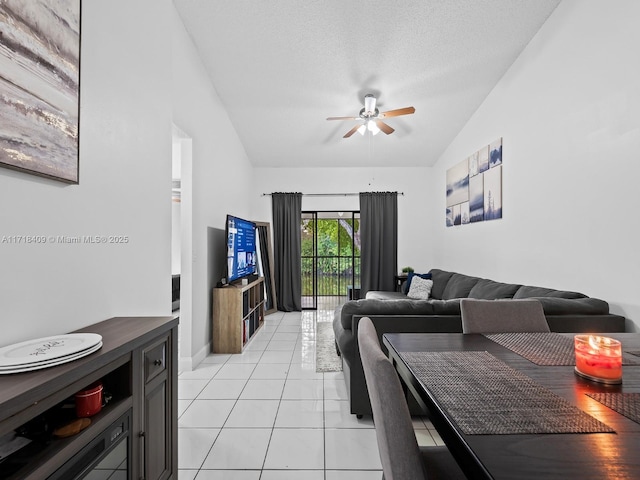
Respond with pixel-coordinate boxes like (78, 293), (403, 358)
(460, 298), (550, 333)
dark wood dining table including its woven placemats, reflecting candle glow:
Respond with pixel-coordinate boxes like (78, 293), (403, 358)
(382, 332), (640, 480)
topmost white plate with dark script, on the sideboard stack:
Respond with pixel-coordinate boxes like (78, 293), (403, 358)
(0, 333), (102, 367)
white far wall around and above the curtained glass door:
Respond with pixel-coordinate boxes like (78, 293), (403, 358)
(251, 166), (436, 271)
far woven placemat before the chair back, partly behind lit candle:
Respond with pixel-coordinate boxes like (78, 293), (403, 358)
(485, 332), (640, 366)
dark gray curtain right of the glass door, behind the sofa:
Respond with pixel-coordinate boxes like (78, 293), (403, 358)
(360, 192), (398, 298)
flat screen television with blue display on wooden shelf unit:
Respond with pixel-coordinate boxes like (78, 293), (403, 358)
(226, 215), (256, 283)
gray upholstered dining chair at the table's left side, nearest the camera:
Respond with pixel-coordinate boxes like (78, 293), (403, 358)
(358, 317), (466, 480)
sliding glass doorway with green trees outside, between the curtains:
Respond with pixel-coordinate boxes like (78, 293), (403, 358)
(300, 211), (360, 310)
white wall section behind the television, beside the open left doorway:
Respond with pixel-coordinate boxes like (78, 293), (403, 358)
(172, 9), (252, 365)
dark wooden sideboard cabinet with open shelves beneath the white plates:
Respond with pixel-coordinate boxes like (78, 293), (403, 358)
(0, 317), (178, 480)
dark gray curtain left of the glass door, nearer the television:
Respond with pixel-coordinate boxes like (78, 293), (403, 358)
(271, 193), (302, 312)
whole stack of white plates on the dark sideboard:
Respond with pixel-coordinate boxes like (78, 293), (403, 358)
(0, 333), (102, 375)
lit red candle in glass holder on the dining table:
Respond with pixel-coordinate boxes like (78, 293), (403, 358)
(574, 335), (622, 384)
